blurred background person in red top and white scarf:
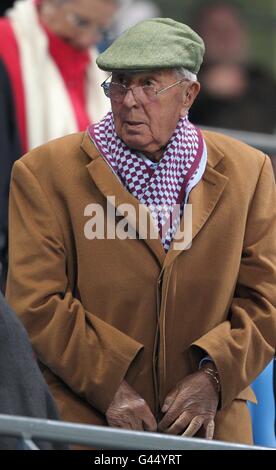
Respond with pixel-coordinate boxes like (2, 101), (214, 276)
(0, 0), (117, 153)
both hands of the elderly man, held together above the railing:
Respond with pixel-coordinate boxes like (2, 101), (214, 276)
(106, 367), (219, 439)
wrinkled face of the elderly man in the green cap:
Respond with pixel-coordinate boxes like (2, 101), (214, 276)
(111, 70), (196, 159)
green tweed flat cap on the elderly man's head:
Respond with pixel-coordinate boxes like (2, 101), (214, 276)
(97, 18), (205, 74)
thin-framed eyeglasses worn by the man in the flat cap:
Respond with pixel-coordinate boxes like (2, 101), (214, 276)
(101, 75), (189, 103)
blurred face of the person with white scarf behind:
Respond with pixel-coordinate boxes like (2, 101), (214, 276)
(40, 0), (117, 50)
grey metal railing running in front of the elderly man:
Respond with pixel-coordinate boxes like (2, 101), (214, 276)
(0, 414), (276, 450)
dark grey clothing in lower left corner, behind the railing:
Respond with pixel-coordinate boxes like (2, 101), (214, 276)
(0, 293), (64, 450)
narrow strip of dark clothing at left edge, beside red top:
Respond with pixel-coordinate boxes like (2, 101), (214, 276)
(0, 57), (20, 289)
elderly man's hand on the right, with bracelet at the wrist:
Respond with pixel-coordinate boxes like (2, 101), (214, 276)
(158, 366), (219, 439)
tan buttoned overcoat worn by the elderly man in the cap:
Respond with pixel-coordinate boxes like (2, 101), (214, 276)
(7, 132), (276, 443)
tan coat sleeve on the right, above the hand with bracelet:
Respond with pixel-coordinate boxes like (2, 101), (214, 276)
(190, 157), (276, 407)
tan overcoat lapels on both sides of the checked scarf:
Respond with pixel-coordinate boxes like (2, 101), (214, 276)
(81, 132), (228, 269)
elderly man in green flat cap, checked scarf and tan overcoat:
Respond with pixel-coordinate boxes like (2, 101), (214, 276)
(7, 18), (276, 443)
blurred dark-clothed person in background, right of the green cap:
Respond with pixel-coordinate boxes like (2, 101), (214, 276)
(190, 1), (276, 133)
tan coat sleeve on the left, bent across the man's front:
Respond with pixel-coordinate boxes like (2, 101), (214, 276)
(7, 160), (143, 413)
